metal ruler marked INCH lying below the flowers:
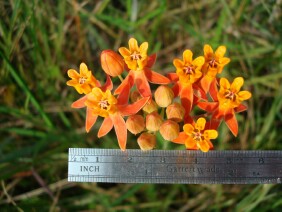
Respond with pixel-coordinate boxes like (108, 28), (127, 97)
(68, 148), (282, 184)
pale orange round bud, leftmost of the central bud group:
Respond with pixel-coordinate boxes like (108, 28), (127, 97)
(126, 115), (145, 135)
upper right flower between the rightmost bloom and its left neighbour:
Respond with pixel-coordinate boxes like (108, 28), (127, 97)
(200, 44), (230, 95)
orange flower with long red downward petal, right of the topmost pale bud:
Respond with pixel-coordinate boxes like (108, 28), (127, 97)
(169, 50), (205, 117)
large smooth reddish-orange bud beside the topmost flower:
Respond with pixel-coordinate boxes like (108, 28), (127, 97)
(100, 50), (124, 77)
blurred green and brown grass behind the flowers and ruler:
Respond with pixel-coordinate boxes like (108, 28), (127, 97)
(0, 0), (282, 211)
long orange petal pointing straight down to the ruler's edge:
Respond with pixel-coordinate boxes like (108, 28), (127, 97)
(110, 114), (127, 151)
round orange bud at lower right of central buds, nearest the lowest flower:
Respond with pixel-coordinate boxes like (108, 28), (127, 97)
(160, 120), (179, 141)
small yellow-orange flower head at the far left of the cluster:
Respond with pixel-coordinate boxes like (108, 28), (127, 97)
(67, 63), (100, 94)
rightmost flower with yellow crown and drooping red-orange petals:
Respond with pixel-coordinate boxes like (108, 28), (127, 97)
(197, 77), (252, 136)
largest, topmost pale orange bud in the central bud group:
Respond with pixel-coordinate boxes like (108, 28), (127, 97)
(155, 85), (174, 107)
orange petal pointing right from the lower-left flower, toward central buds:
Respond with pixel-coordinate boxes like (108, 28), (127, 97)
(118, 97), (150, 116)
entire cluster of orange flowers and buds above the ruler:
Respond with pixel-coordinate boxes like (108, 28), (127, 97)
(67, 38), (251, 152)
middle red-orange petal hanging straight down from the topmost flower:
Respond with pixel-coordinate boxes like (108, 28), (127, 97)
(134, 71), (152, 97)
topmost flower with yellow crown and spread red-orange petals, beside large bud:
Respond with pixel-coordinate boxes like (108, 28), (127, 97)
(115, 38), (170, 97)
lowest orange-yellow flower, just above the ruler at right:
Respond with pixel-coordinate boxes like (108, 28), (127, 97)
(173, 118), (218, 152)
